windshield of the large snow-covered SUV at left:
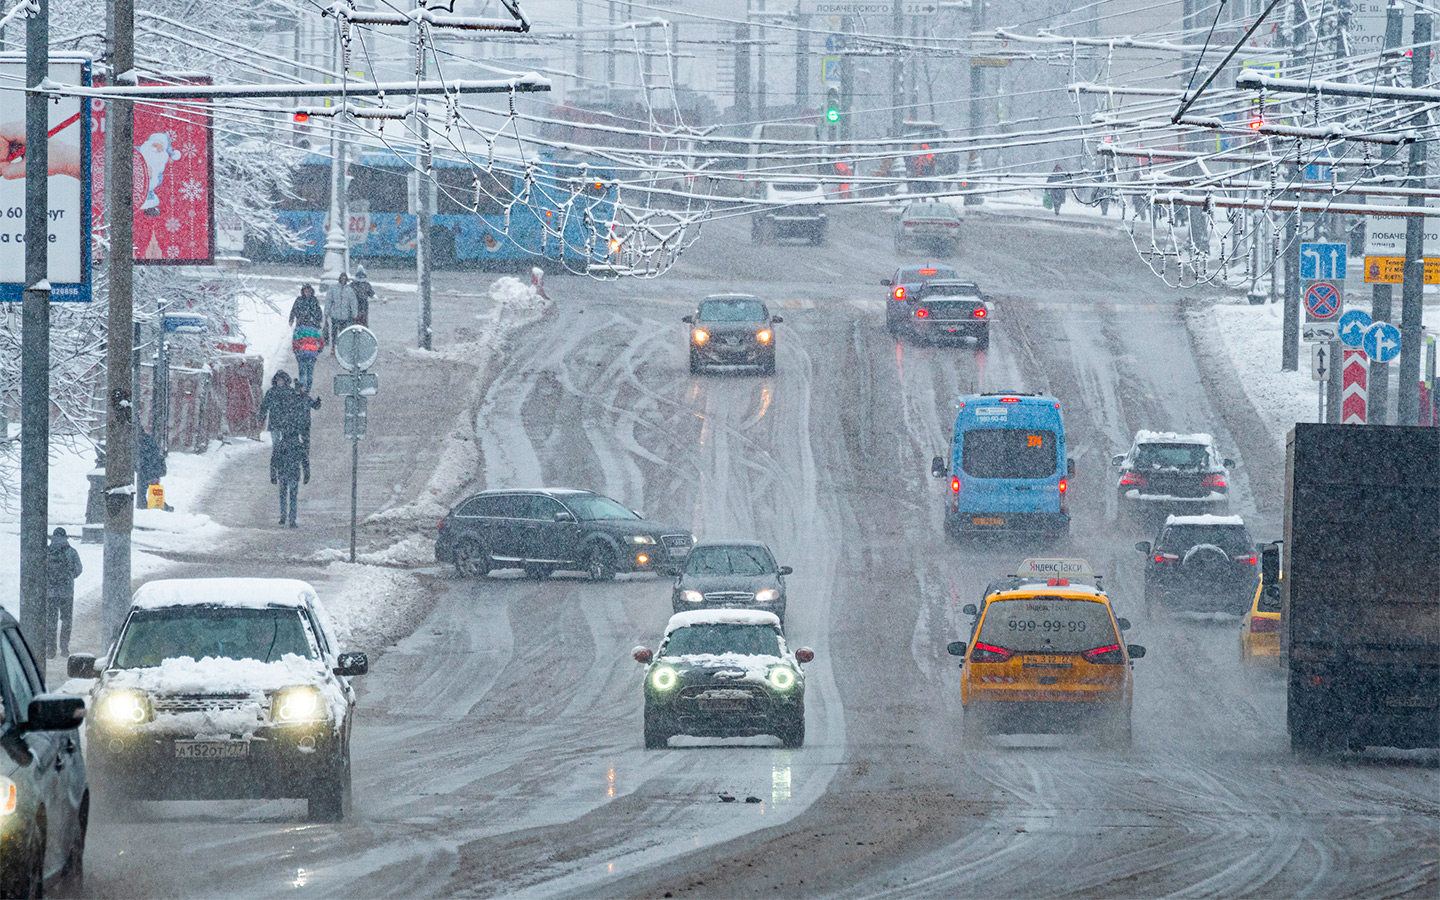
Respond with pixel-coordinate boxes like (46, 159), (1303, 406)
(114, 606), (315, 668)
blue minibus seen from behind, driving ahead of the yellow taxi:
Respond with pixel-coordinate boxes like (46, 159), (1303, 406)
(930, 393), (1074, 539)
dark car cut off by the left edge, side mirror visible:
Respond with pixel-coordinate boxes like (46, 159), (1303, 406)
(0, 609), (91, 897)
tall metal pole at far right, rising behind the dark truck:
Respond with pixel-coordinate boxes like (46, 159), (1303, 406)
(1381, 7), (1431, 425)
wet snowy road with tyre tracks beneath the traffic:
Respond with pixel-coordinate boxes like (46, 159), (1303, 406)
(86, 211), (1440, 897)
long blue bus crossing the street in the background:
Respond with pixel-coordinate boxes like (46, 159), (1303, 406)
(245, 150), (615, 271)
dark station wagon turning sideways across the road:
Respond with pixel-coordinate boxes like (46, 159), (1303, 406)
(435, 488), (696, 582)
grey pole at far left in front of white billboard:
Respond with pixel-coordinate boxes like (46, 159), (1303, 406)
(20, 0), (49, 641)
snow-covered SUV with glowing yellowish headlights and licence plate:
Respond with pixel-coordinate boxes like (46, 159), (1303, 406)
(69, 577), (370, 822)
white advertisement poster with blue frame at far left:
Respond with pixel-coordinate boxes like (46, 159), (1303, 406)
(0, 56), (91, 302)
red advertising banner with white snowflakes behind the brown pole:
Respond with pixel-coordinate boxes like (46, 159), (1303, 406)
(91, 75), (215, 265)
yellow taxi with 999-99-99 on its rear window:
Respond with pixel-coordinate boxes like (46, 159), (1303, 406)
(948, 559), (1145, 747)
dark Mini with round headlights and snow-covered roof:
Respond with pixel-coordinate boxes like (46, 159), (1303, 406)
(632, 609), (815, 750)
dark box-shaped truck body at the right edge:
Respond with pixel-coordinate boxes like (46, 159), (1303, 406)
(1280, 423), (1440, 753)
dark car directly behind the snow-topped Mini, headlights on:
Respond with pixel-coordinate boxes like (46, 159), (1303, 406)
(670, 541), (792, 625)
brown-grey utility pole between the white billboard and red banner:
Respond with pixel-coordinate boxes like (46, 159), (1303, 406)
(99, 0), (140, 647)
